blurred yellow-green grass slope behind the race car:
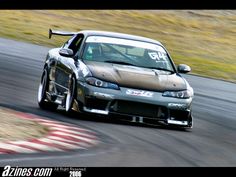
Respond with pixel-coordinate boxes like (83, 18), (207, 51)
(0, 10), (236, 83)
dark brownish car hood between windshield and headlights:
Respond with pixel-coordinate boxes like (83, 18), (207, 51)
(84, 61), (187, 91)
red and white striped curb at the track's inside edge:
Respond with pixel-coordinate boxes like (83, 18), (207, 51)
(0, 111), (99, 154)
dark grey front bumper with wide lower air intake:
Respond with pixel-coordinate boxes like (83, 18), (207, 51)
(77, 82), (192, 126)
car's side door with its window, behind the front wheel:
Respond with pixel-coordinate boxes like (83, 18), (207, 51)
(55, 34), (83, 95)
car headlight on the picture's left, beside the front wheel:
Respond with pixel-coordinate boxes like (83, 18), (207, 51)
(85, 77), (119, 90)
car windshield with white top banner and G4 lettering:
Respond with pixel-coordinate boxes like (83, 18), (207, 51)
(82, 36), (174, 72)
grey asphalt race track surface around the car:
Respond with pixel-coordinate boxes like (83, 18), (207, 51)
(0, 39), (236, 167)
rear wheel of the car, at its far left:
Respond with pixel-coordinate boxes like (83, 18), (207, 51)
(38, 68), (58, 110)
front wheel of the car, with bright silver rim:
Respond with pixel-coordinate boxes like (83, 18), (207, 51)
(65, 76), (76, 113)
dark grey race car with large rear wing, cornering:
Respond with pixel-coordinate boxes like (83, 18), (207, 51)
(38, 29), (194, 128)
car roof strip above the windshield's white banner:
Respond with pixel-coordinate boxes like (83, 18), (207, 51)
(78, 30), (163, 46)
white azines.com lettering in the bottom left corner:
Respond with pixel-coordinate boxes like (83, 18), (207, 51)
(2, 165), (53, 177)
